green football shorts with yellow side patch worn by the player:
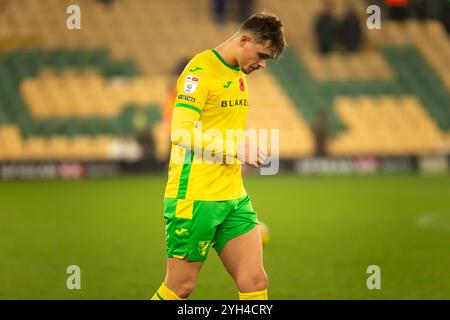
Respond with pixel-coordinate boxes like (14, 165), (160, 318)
(164, 195), (259, 261)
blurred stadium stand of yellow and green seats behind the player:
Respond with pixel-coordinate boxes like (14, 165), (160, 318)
(0, 0), (450, 161)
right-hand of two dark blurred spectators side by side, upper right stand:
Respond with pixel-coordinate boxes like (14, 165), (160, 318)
(338, 7), (363, 52)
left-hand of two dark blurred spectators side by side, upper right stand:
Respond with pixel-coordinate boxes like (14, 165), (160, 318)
(315, 0), (337, 54)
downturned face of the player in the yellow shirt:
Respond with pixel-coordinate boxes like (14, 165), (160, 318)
(239, 39), (273, 74)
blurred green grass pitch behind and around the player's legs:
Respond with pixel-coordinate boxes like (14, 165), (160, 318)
(0, 175), (450, 299)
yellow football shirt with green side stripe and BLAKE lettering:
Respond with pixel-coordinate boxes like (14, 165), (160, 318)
(165, 50), (249, 201)
